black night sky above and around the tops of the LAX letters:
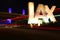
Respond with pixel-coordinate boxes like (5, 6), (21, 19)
(0, 0), (60, 14)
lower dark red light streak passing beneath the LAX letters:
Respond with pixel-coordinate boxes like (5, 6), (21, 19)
(0, 24), (60, 30)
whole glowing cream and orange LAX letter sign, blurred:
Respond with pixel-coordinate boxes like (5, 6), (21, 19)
(28, 2), (56, 28)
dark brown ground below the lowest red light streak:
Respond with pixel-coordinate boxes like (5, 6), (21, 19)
(0, 28), (60, 40)
